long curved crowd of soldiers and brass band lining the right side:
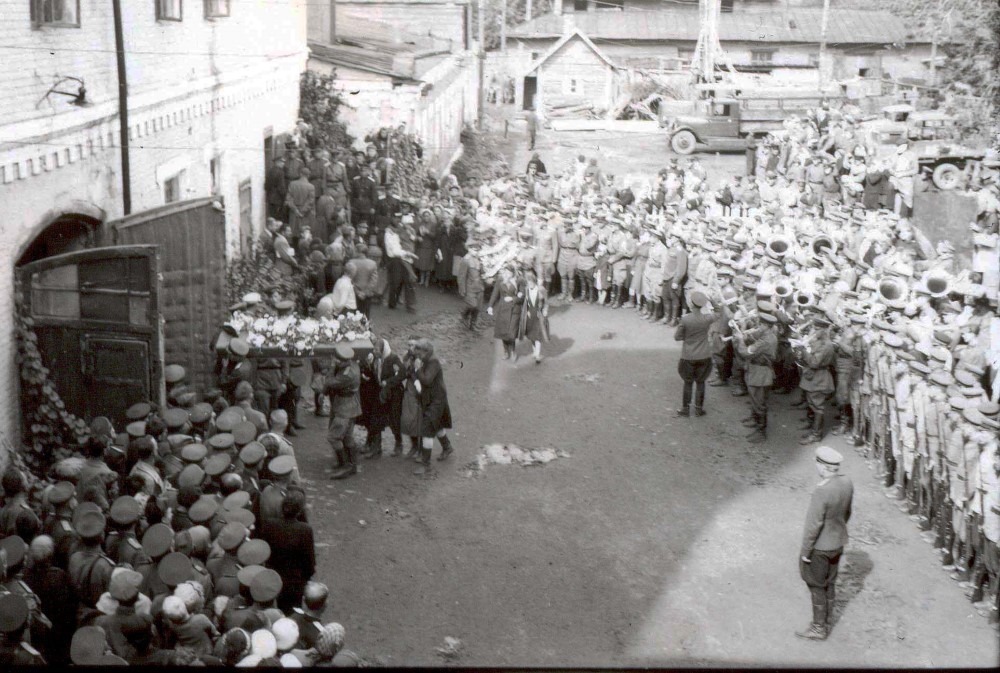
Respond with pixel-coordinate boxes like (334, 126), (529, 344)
(452, 129), (1000, 619)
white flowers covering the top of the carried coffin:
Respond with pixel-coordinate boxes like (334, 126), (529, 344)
(229, 311), (372, 355)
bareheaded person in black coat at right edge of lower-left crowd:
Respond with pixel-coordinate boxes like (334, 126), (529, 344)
(261, 490), (316, 613)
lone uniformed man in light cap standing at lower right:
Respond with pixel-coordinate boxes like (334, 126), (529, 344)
(795, 446), (854, 640)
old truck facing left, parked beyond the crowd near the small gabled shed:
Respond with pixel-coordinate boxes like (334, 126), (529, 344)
(659, 98), (815, 154)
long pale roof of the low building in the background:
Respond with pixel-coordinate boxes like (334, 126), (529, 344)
(509, 7), (925, 44)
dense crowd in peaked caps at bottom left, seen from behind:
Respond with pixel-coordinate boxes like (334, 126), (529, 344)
(0, 365), (360, 667)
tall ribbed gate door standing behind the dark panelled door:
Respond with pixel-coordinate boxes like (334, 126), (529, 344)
(107, 198), (229, 390)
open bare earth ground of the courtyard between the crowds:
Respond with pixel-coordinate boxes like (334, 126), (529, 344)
(295, 289), (998, 667)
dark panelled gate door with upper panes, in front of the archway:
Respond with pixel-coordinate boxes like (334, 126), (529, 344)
(18, 245), (163, 427)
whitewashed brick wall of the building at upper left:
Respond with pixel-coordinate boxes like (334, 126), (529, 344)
(0, 0), (306, 464)
